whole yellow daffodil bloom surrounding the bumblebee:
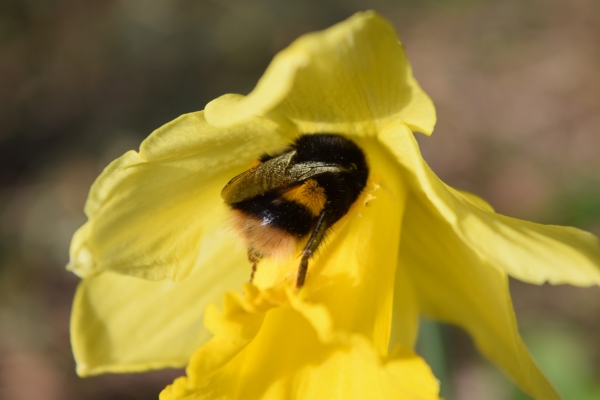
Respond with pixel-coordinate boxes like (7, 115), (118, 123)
(69, 12), (600, 400)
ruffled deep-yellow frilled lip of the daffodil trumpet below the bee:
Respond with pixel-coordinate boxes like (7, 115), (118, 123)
(160, 289), (438, 400)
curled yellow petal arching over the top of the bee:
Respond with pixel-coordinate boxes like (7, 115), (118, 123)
(206, 11), (435, 135)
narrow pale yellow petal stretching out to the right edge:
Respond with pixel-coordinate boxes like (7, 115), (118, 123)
(380, 125), (600, 286)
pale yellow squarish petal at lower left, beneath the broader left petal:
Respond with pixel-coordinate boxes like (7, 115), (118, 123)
(71, 223), (249, 376)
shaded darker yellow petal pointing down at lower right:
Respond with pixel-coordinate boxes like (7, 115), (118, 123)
(400, 198), (560, 400)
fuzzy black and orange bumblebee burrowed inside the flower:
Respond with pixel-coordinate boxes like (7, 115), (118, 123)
(221, 133), (369, 288)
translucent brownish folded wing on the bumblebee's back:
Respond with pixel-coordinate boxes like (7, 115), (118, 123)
(221, 151), (344, 204)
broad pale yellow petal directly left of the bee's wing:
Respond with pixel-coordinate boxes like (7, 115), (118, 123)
(68, 112), (286, 280)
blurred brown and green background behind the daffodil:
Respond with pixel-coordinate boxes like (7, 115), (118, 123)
(0, 0), (600, 400)
